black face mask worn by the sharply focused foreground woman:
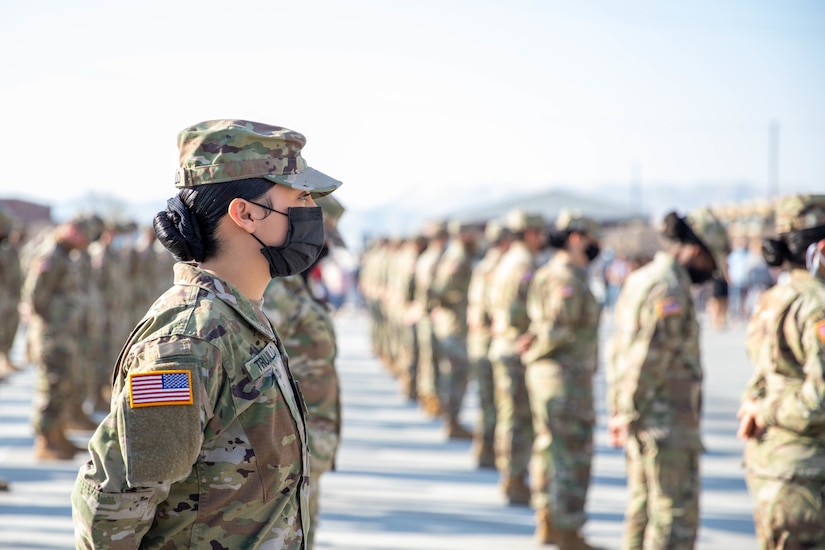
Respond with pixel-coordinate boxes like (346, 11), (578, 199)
(249, 205), (324, 279)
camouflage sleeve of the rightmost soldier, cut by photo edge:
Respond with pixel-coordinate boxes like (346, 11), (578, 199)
(762, 300), (825, 435)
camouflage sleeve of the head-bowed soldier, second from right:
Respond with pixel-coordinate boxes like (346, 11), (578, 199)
(615, 285), (688, 424)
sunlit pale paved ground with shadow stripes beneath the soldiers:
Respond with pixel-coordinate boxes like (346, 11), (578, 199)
(0, 315), (756, 550)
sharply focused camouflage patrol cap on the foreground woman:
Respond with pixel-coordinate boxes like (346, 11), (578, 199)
(175, 120), (341, 197)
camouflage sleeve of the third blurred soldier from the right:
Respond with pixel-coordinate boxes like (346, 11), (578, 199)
(522, 270), (582, 363)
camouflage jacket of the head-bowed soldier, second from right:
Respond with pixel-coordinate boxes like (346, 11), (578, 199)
(608, 252), (703, 451)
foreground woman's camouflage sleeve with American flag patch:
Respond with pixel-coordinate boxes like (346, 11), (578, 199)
(72, 339), (216, 549)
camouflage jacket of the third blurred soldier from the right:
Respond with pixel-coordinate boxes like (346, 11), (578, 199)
(522, 252), (600, 374)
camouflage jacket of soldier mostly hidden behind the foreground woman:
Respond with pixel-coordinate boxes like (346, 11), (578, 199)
(264, 275), (341, 472)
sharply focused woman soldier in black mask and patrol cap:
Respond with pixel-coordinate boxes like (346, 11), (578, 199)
(72, 120), (340, 549)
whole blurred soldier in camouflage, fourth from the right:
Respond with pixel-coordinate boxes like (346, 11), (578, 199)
(490, 210), (545, 505)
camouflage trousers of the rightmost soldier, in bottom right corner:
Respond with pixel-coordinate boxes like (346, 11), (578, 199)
(745, 472), (825, 550)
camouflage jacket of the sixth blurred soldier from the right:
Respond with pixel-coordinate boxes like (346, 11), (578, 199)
(431, 239), (473, 338)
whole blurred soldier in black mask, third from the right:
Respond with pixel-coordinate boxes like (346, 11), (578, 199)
(519, 211), (601, 550)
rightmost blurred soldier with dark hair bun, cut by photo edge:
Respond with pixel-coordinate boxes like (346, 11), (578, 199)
(738, 195), (825, 550)
